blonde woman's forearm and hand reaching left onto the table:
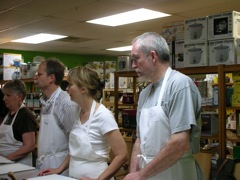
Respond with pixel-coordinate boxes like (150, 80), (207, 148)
(38, 155), (70, 176)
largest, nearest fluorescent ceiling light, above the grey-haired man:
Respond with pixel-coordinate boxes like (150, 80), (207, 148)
(87, 8), (170, 26)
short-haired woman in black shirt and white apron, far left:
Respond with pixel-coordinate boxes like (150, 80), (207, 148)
(0, 80), (37, 166)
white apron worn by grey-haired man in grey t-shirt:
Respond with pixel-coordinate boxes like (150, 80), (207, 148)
(138, 67), (202, 180)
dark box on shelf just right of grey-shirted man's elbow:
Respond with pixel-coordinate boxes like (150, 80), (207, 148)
(201, 112), (218, 136)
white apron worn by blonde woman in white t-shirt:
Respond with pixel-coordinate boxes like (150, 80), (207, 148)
(69, 101), (112, 179)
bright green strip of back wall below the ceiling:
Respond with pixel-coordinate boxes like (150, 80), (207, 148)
(0, 49), (117, 68)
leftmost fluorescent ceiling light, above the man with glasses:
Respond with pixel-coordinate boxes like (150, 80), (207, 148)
(11, 33), (67, 44)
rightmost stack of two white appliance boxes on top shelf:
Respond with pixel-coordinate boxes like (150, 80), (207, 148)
(208, 11), (240, 66)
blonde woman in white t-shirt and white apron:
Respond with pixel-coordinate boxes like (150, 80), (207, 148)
(40, 67), (127, 180)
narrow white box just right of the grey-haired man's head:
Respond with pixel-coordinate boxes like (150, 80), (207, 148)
(174, 40), (184, 68)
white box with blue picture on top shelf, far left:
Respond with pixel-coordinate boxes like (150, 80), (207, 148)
(0, 53), (22, 80)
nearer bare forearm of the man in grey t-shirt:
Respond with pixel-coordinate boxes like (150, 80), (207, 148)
(124, 131), (189, 180)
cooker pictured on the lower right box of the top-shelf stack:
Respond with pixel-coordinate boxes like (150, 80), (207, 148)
(213, 46), (230, 62)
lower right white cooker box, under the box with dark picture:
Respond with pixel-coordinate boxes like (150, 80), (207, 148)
(209, 39), (236, 66)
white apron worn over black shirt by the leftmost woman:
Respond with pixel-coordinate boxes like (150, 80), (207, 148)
(0, 104), (32, 166)
